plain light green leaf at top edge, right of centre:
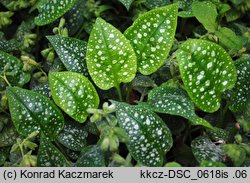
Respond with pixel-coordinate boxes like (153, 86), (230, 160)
(192, 1), (218, 32)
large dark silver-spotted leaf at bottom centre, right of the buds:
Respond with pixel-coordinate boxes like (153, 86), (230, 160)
(115, 102), (173, 166)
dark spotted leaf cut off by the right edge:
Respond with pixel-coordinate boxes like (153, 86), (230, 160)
(230, 57), (250, 112)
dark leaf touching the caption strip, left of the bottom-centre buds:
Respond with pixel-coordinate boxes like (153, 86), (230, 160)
(76, 145), (105, 167)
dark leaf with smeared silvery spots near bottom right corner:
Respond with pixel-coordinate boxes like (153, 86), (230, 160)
(191, 136), (225, 163)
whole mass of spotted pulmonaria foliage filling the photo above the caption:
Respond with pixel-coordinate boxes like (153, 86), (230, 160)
(0, 0), (250, 167)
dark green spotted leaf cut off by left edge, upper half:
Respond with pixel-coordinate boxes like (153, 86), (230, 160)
(0, 51), (30, 87)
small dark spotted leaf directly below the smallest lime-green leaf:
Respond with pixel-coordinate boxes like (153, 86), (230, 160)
(58, 122), (88, 151)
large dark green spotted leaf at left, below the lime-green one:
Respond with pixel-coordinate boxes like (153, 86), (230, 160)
(7, 87), (64, 140)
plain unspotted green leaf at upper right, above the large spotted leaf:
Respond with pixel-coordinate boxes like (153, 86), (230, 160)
(215, 27), (244, 51)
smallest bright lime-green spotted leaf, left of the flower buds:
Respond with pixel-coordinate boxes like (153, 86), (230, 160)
(49, 72), (99, 123)
